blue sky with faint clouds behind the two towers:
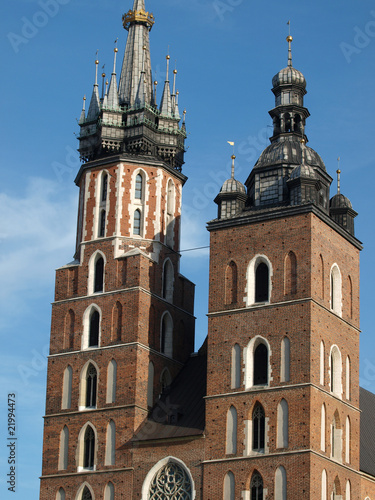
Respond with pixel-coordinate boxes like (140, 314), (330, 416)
(0, 0), (375, 500)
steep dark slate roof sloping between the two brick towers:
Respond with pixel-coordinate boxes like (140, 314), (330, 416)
(132, 346), (207, 443)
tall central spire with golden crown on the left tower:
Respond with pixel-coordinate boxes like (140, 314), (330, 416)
(119, 0), (155, 106)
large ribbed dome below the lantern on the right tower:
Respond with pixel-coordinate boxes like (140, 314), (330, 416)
(254, 137), (326, 171)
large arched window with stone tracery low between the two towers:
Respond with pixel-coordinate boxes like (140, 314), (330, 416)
(147, 461), (192, 500)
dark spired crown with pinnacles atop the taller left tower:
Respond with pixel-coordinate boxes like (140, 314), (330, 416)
(79, 0), (186, 171)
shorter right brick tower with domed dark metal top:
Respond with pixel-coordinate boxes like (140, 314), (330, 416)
(202, 36), (361, 500)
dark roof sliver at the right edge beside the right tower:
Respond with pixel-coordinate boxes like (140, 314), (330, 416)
(359, 387), (375, 476)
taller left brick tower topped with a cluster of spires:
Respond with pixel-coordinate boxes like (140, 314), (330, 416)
(40, 0), (194, 500)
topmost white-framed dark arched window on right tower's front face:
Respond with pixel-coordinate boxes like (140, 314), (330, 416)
(247, 254), (273, 306)
